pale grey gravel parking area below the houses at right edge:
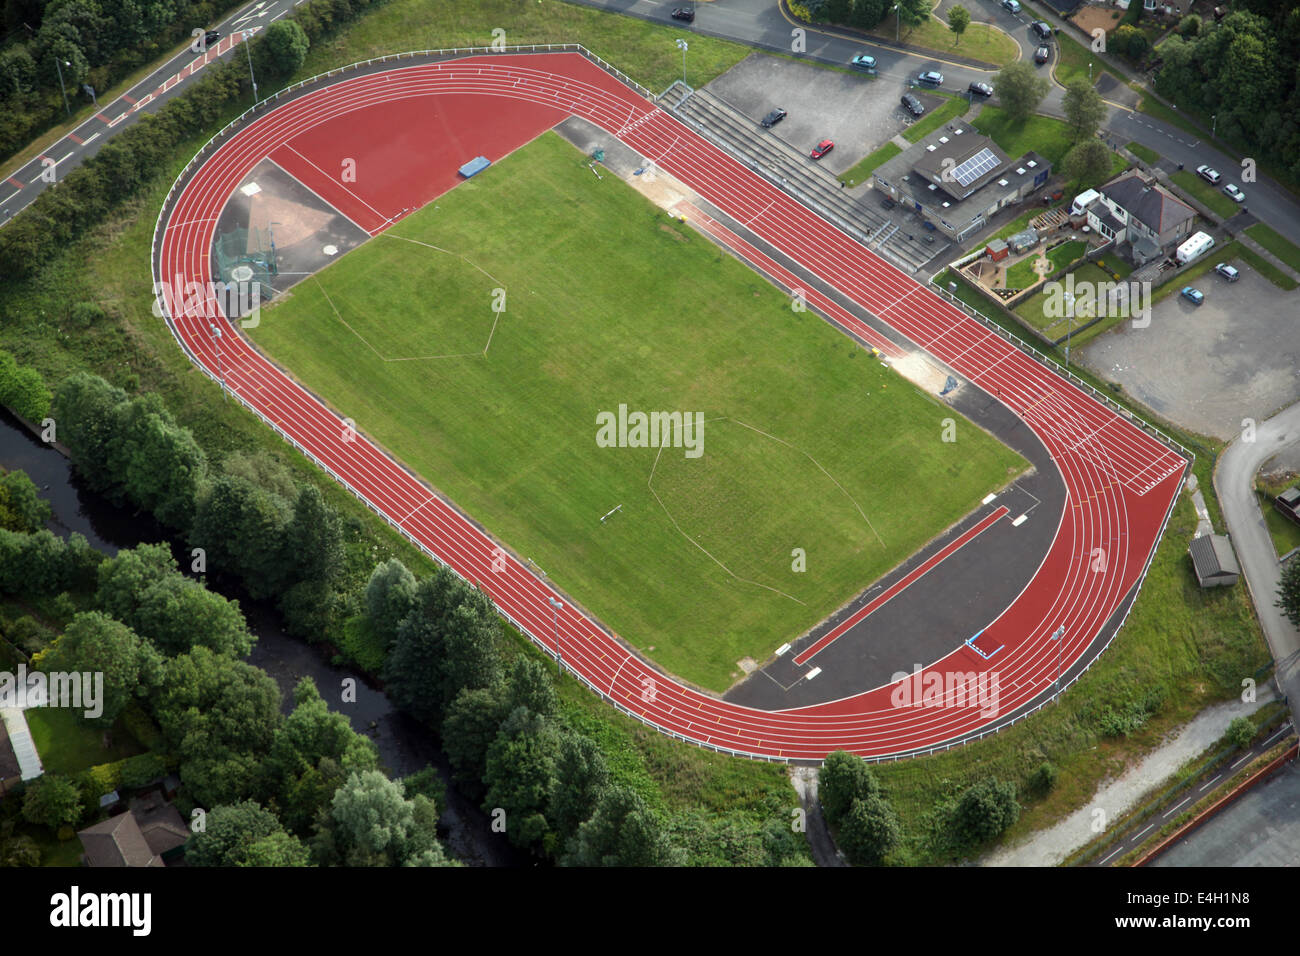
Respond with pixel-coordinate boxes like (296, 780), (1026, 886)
(1076, 264), (1300, 441)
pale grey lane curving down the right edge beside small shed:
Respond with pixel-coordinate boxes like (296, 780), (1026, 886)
(1214, 403), (1300, 727)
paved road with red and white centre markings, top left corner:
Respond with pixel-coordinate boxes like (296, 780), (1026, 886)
(0, 0), (303, 226)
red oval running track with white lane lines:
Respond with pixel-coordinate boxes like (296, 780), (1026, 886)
(155, 53), (1187, 760)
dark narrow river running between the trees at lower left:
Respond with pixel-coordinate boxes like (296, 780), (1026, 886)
(0, 408), (533, 866)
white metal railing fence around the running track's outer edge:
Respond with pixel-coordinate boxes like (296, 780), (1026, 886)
(152, 43), (1193, 763)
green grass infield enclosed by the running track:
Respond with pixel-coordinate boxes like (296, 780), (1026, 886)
(254, 134), (1023, 689)
